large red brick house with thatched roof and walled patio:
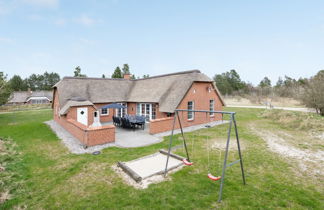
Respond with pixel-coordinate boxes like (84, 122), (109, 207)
(52, 70), (224, 146)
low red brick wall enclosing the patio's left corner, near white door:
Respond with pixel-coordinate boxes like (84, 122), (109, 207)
(56, 118), (115, 146)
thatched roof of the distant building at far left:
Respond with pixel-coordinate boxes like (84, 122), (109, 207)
(8, 90), (53, 103)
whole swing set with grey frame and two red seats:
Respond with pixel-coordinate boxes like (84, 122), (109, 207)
(164, 109), (246, 202)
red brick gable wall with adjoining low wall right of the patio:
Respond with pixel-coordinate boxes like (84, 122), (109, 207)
(150, 82), (222, 134)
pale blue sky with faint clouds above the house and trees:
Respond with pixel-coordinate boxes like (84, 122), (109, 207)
(0, 0), (324, 84)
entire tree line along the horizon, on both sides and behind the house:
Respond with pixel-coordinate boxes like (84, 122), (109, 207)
(0, 64), (324, 116)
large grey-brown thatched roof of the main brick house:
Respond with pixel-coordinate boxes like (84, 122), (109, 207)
(54, 70), (225, 112)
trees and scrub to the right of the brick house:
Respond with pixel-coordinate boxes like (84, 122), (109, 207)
(213, 69), (324, 116)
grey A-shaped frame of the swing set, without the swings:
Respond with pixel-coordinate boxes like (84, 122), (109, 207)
(164, 109), (246, 202)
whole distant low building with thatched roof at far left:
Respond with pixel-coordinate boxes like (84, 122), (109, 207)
(7, 91), (53, 105)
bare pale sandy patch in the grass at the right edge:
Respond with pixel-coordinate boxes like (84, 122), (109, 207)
(250, 124), (324, 176)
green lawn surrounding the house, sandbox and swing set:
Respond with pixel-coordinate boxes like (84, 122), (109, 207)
(0, 108), (324, 209)
